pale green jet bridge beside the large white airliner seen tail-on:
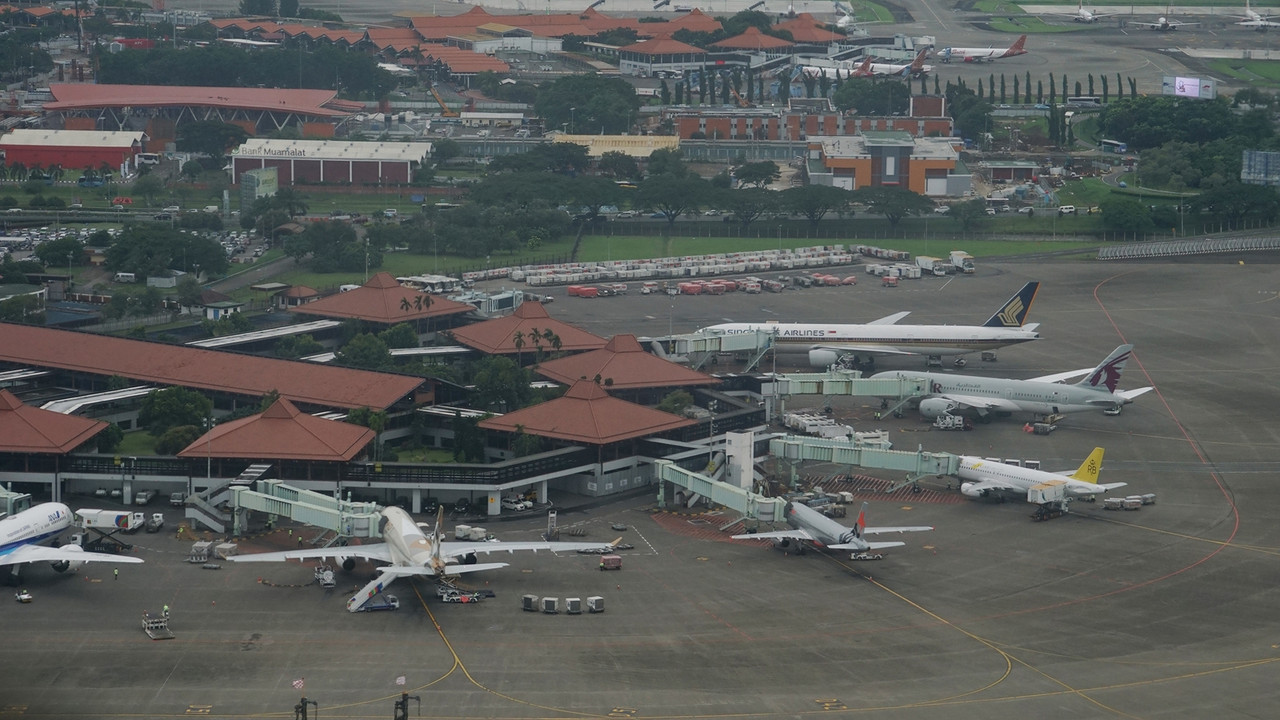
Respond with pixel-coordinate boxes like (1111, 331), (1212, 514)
(232, 480), (381, 544)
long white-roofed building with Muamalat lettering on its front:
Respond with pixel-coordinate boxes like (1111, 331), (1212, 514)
(232, 138), (431, 184)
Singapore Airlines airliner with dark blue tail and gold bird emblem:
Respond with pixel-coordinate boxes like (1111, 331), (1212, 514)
(699, 282), (1039, 368)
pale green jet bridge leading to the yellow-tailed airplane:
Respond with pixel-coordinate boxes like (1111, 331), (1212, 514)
(769, 436), (960, 492)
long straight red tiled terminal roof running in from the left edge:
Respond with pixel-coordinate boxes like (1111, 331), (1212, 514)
(0, 323), (422, 410)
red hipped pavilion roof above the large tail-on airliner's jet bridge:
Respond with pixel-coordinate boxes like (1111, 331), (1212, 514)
(178, 397), (375, 462)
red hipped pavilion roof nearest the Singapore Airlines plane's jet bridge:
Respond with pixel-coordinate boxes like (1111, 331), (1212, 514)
(538, 334), (719, 389)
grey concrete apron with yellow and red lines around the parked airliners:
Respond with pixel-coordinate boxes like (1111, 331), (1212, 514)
(0, 259), (1280, 720)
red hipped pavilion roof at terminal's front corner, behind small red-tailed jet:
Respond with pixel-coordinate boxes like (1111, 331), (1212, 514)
(480, 380), (694, 445)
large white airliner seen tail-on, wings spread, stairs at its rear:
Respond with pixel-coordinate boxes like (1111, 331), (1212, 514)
(228, 507), (612, 612)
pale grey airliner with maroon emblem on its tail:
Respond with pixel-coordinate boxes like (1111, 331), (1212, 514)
(874, 345), (1151, 419)
